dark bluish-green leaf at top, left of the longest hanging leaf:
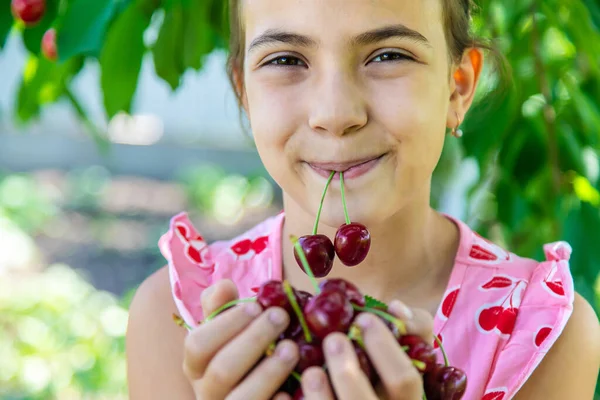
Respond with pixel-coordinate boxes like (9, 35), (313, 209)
(56, 0), (121, 61)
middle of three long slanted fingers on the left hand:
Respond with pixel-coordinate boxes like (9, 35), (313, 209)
(202, 303), (290, 399)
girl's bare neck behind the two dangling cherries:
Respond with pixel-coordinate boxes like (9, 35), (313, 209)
(282, 192), (460, 312)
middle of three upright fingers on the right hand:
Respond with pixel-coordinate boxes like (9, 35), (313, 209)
(323, 332), (376, 400)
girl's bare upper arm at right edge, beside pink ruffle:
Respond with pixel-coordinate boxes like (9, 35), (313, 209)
(515, 294), (600, 400)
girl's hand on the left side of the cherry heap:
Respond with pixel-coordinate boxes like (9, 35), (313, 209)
(183, 281), (298, 400)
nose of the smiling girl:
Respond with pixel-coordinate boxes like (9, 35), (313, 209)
(309, 73), (368, 136)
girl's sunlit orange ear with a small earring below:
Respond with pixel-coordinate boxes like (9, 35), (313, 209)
(447, 48), (483, 129)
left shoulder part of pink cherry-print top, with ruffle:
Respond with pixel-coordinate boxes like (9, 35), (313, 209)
(158, 212), (284, 327)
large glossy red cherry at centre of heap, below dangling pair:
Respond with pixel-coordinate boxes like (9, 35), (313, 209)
(304, 289), (354, 339)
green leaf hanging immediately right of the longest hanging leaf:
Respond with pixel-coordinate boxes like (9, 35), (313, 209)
(152, 1), (185, 90)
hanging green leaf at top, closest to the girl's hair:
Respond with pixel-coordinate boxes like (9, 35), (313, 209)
(183, 0), (216, 70)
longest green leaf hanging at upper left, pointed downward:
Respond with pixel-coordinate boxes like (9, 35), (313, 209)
(100, 3), (150, 118)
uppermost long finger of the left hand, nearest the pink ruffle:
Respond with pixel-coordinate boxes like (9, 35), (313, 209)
(183, 303), (262, 381)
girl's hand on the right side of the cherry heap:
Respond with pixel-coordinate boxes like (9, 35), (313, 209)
(302, 301), (433, 400)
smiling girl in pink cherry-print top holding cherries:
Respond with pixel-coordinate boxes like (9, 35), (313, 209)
(127, 0), (600, 400)
